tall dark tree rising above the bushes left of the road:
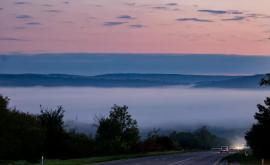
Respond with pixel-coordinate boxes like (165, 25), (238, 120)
(96, 105), (139, 153)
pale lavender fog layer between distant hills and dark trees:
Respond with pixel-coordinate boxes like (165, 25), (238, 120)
(0, 87), (269, 129)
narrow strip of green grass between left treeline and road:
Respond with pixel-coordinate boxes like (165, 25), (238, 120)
(0, 151), (183, 165)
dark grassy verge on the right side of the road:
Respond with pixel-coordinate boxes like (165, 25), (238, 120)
(223, 152), (270, 165)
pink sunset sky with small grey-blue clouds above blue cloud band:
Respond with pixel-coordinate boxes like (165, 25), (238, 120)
(0, 0), (270, 56)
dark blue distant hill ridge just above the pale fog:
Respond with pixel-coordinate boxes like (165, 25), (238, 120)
(0, 73), (268, 89)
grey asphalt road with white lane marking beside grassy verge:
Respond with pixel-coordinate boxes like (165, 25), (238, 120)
(97, 151), (226, 165)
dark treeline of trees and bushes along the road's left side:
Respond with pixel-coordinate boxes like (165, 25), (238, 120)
(0, 95), (229, 162)
